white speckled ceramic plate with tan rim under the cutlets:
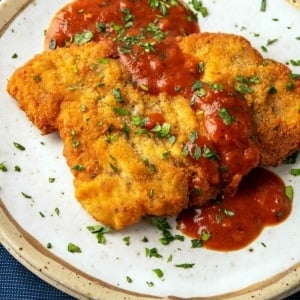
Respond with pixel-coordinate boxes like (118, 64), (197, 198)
(0, 0), (300, 299)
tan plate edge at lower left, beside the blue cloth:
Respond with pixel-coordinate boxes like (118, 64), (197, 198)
(0, 199), (163, 300)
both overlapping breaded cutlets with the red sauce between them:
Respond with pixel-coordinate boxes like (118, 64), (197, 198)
(8, 33), (300, 229)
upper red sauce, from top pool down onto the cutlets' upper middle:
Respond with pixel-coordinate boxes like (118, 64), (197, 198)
(45, 0), (199, 95)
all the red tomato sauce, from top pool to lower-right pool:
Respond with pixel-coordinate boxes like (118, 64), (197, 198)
(45, 0), (291, 251)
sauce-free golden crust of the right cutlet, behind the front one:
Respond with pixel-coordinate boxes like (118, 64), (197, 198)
(180, 33), (300, 166)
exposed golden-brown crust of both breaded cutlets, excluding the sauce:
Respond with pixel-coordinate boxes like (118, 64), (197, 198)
(8, 33), (300, 229)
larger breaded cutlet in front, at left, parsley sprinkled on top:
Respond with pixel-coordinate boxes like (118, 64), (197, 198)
(8, 37), (259, 229)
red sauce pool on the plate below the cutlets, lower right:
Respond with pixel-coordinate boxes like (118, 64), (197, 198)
(177, 168), (292, 251)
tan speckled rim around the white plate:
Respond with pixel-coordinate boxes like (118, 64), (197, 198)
(0, 0), (300, 300)
